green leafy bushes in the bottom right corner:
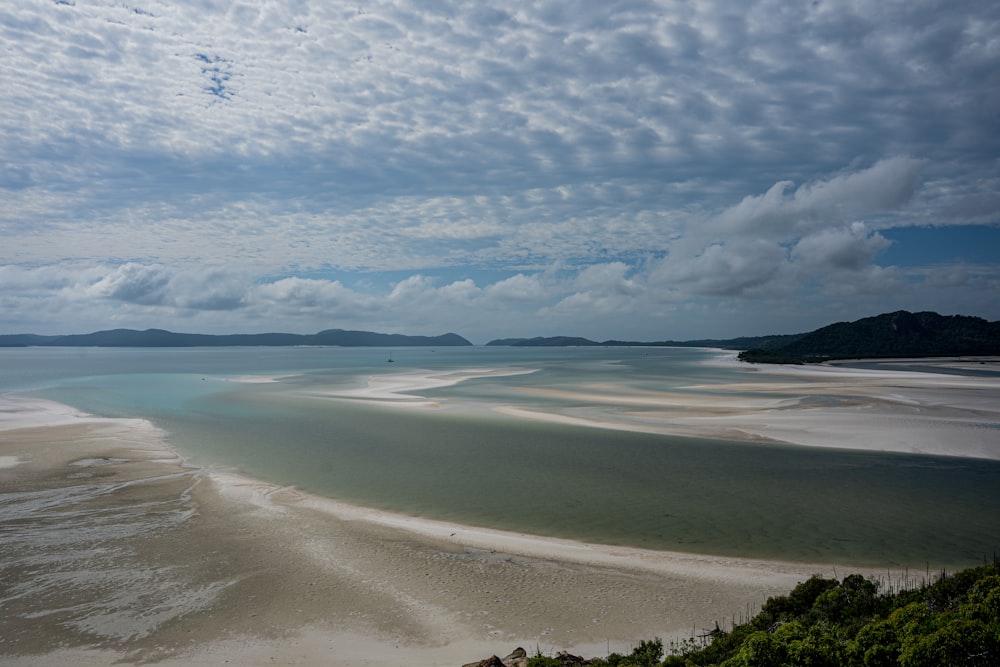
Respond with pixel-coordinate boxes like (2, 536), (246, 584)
(528, 559), (1000, 667)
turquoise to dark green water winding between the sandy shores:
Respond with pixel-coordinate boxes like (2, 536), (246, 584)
(0, 347), (1000, 570)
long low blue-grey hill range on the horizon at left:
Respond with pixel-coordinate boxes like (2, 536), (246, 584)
(0, 329), (472, 347)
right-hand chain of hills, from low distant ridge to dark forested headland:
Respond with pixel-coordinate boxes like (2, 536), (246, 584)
(487, 310), (1000, 364)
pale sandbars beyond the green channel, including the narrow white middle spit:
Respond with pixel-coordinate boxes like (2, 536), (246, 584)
(286, 352), (1000, 460)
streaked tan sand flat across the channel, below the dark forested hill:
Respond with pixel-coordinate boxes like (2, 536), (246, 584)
(496, 355), (1000, 460)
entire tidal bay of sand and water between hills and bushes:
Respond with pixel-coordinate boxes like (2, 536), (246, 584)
(0, 350), (1000, 665)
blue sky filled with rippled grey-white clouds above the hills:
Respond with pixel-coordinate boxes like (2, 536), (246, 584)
(0, 0), (1000, 344)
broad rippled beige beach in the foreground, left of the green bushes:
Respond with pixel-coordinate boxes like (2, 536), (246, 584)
(0, 396), (908, 666)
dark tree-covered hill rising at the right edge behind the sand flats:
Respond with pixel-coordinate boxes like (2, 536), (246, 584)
(740, 310), (1000, 364)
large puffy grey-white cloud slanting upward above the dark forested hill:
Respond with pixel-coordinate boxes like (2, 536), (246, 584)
(651, 158), (924, 296)
